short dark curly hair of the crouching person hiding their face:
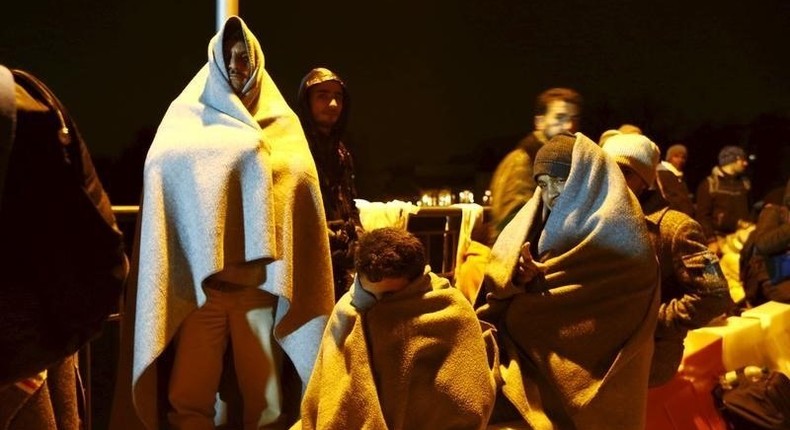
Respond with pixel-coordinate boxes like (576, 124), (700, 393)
(354, 227), (425, 282)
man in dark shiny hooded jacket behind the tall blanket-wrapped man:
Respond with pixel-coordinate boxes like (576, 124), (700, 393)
(296, 67), (362, 300)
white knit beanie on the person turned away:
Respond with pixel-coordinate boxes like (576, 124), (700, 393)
(603, 134), (661, 186)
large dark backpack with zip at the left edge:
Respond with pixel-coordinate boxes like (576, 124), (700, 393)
(0, 67), (128, 386)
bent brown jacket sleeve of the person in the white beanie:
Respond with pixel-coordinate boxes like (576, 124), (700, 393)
(659, 214), (732, 331)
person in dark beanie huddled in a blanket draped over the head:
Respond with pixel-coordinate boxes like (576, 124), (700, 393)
(478, 133), (659, 429)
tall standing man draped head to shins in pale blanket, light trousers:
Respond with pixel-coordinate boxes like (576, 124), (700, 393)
(110, 17), (334, 429)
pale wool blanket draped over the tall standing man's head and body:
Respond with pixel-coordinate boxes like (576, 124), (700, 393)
(114, 17), (334, 428)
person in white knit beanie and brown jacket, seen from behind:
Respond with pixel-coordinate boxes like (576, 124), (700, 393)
(603, 134), (734, 387)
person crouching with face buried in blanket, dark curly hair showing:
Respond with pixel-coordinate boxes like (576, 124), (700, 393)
(294, 227), (496, 430)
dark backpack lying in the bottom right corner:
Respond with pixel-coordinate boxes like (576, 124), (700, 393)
(713, 366), (790, 430)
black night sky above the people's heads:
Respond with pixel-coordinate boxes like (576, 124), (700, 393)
(0, 0), (790, 203)
